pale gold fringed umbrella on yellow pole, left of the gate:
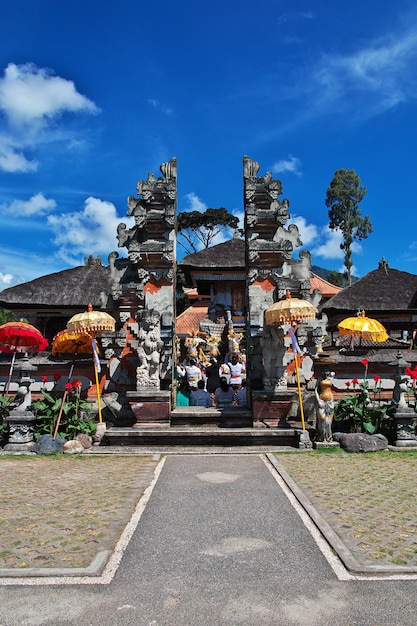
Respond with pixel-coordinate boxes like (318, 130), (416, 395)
(67, 304), (116, 423)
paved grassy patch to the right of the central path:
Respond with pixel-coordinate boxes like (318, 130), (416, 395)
(276, 451), (417, 567)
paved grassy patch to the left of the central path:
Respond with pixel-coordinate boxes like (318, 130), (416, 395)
(0, 455), (159, 575)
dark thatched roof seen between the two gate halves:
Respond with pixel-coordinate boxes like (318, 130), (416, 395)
(179, 238), (245, 269)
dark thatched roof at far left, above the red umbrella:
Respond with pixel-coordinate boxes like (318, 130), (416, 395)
(0, 265), (111, 309)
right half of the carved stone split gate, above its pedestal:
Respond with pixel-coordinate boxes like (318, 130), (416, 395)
(243, 156), (324, 428)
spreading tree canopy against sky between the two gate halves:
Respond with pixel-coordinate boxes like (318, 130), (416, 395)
(177, 207), (239, 254)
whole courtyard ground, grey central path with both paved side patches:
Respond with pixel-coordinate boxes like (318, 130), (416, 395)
(0, 447), (417, 626)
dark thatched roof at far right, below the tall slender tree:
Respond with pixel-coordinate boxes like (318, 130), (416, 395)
(323, 267), (417, 315)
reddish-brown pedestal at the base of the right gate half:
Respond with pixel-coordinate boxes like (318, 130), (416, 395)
(252, 388), (297, 428)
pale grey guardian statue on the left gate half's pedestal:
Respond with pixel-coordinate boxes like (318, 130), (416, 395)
(136, 309), (164, 390)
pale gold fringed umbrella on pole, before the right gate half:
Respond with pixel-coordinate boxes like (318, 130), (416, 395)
(265, 291), (317, 430)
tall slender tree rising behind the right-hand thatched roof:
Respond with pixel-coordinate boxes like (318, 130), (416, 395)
(326, 169), (372, 285)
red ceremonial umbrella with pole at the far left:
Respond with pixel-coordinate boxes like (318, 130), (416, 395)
(0, 320), (48, 395)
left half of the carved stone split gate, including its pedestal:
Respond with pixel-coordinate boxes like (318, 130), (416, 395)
(109, 158), (177, 423)
